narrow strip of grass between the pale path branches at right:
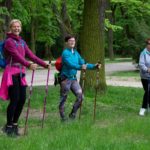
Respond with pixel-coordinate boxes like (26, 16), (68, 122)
(111, 70), (140, 77)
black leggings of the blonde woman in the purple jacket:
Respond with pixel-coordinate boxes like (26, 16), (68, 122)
(7, 75), (26, 125)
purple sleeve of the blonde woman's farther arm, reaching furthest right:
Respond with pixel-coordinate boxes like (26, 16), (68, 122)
(25, 43), (47, 68)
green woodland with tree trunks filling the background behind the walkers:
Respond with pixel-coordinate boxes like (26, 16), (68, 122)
(0, 0), (150, 89)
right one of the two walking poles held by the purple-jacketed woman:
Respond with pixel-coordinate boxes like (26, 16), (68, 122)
(42, 61), (51, 128)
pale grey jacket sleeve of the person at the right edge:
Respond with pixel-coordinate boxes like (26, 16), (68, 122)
(139, 52), (148, 73)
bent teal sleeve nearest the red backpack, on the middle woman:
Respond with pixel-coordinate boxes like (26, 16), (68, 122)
(62, 51), (81, 70)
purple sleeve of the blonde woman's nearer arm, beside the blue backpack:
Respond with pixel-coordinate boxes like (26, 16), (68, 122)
(4, 40), (30, 67)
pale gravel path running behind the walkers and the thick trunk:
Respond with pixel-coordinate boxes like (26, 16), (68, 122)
(0, 62), (142, 87)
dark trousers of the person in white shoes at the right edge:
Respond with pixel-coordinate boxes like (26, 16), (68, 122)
(141, 79), (150, 108)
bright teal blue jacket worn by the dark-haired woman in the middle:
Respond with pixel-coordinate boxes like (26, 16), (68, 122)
(61, 48), (96, 80)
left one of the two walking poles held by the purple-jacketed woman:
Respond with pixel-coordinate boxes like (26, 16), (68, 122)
(24, 70), (34, 135)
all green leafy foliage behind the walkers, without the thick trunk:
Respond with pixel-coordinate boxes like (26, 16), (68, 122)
(0, 0), (150, 59)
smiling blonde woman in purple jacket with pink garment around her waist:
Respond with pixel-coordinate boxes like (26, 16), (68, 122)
(0, 19), (50, 136)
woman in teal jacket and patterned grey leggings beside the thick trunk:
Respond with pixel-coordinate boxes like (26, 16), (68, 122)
(59, 36), (100, 121)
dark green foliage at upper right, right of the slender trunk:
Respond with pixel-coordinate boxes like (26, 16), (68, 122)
(108, 0), (150, 59)
